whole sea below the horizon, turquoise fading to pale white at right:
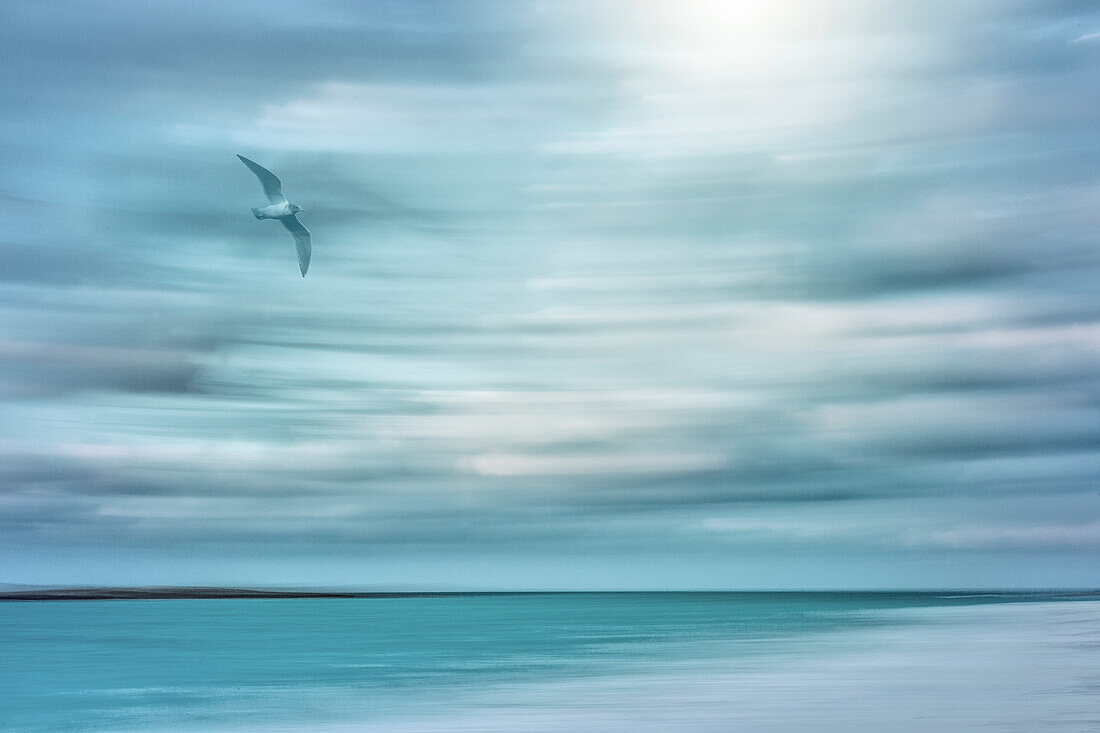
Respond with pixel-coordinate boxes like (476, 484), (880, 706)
(0, 592), (1100, 733)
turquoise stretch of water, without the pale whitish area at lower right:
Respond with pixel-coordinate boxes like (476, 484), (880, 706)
(0, 593), (1098, 731)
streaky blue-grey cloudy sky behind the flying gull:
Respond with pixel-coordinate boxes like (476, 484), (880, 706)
(0, 0), (1100, 590)
